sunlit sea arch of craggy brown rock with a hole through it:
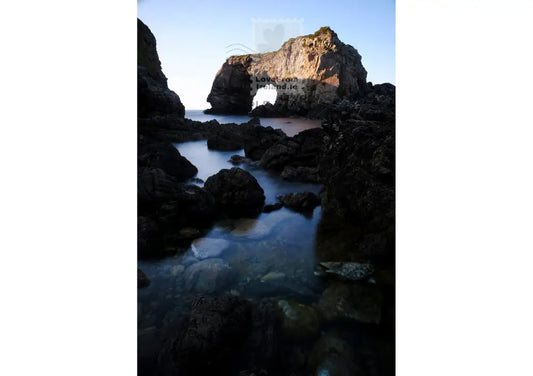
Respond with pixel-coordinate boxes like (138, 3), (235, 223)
(207, 27), (367, 115)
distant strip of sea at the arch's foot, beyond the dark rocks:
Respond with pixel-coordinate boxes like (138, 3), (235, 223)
(185, 110), (321, 137)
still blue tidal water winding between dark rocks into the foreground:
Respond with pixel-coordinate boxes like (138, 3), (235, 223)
(138, 115), (393, 375)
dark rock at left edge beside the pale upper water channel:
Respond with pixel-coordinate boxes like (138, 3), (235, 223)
(138, 143), (198, 181)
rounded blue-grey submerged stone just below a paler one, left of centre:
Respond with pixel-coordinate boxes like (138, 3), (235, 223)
(184, 258), (233, 293)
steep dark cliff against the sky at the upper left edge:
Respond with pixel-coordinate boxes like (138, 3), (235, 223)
(137, 19), (185, 118)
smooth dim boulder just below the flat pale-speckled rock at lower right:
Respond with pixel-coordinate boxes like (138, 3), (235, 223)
(318, 283), (382, 324)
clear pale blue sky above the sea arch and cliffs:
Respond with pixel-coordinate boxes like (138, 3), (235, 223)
(137, 0), (395, 109)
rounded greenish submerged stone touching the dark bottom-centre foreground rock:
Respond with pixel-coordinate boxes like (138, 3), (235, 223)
(278, 300), (320, 341)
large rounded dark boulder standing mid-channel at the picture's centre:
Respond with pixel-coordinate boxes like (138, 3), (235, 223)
(204, 167), (265, 217)
